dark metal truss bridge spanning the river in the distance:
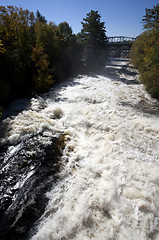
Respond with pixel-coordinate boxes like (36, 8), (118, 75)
(107, 36), (136, 57)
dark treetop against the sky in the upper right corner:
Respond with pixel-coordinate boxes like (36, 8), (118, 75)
(142, 4), (159, 29)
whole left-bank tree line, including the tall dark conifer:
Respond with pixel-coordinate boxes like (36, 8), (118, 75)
(0, 6), (107, 116)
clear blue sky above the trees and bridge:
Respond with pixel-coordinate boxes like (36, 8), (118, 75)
(0, 0), (159, 37)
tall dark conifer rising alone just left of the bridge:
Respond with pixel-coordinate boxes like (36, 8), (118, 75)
(81, 10), (107, 69)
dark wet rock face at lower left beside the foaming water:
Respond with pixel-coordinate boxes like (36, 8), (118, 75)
(0, 133), (64, 240)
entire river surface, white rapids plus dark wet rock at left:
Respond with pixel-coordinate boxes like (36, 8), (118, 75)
(1, 59), (159, 240)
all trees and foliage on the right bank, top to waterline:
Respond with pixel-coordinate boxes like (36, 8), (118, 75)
(130, 4), (159, 99)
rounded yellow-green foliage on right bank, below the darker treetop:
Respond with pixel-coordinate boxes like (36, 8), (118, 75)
(130, 25), (159, 99)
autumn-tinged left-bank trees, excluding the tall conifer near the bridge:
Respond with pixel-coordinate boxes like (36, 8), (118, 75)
(0, 6), (80, 106)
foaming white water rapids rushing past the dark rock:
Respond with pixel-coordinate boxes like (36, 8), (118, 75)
(1, 60), (159, 240)
